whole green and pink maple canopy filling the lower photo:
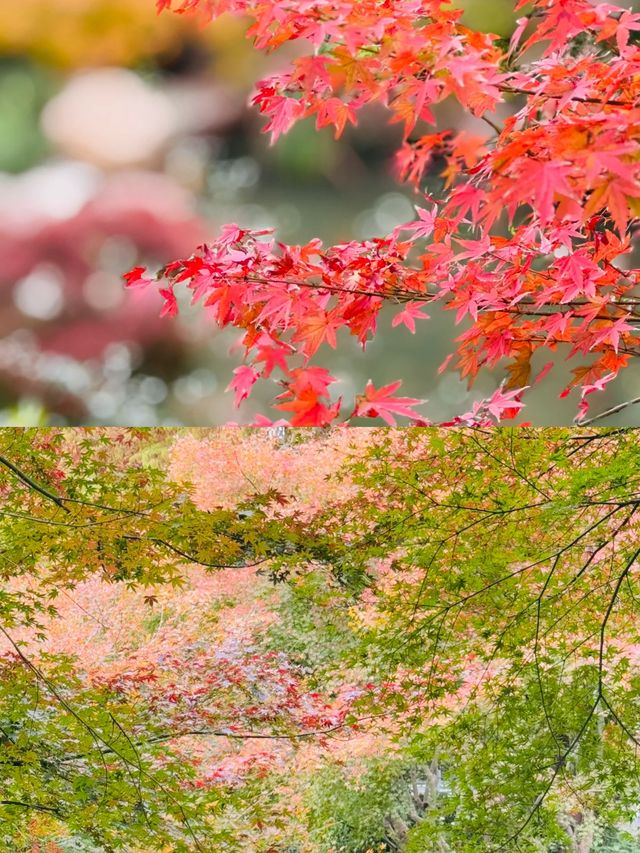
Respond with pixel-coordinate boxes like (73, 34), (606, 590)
(0, 428), (640, 853)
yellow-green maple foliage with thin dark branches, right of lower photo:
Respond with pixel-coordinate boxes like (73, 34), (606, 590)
(296, 429), (640, 853)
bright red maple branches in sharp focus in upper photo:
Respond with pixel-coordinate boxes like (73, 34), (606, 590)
(126, 0), (640, 426)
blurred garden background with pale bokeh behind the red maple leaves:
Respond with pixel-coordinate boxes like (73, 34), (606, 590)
(0, 0), (637, 426)
